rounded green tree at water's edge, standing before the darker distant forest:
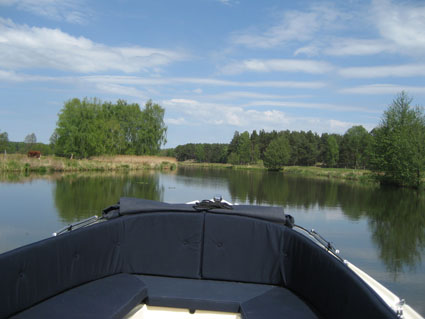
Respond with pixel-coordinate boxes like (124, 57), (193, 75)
(264, 135), (291, 170)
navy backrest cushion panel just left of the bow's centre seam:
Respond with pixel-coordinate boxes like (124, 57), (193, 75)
(121, 213), (204, 278)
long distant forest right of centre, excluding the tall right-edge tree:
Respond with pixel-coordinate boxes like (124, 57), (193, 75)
(173, 126), (372, 169)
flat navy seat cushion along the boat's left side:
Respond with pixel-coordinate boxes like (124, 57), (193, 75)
(12, 274), (147, 319)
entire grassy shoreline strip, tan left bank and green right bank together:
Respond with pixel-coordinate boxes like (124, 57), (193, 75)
(0, 154), (377, 184)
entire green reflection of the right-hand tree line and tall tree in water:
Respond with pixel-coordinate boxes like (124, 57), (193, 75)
(222, 170), (425, 273)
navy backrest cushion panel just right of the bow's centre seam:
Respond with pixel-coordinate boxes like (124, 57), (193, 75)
(202, 213), (283, 285)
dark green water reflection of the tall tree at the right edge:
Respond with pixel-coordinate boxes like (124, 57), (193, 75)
(340, 188), (425, 273)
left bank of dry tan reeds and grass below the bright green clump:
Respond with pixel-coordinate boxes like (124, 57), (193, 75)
(0, 154), (177, 173)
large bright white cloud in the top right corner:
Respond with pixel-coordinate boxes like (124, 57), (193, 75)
(294, 0), (425, 56)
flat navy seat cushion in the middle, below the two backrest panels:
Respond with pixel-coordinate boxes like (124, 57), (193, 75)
(140, 276), (275, 312)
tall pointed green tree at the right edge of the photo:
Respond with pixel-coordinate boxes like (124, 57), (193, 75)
(373, 92), (425, 187)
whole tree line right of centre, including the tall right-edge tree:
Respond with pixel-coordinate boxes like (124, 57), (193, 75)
(173, 92), (425, 188)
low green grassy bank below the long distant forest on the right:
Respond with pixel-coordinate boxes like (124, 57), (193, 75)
(178, 161), (376, 183)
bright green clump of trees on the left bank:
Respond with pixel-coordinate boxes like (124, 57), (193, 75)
(50, 98), (167, 158)
